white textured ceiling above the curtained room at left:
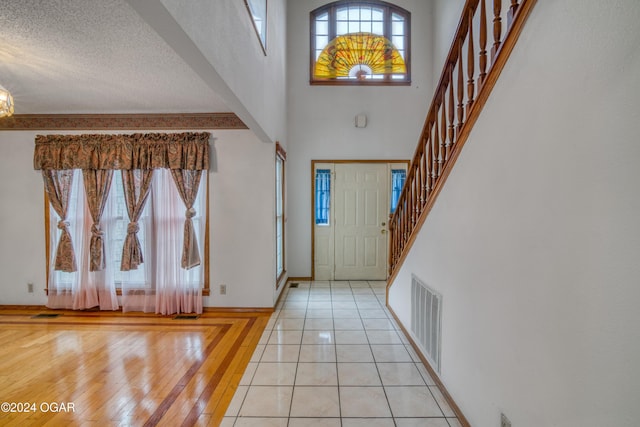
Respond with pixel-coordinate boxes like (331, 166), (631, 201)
(0, 0), (231, 114)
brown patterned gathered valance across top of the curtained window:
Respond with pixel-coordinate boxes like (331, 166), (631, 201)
(33, 132), (210, 170)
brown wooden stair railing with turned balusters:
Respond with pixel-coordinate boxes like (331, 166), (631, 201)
(388, 0), (536, 285)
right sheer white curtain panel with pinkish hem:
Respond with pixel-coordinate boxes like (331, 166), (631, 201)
(121, 169), (207, 314)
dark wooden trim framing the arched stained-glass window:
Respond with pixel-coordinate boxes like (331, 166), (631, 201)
(309, 0), (411, 86)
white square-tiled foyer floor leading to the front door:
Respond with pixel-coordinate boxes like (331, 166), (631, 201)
(222, 281), (460, 427)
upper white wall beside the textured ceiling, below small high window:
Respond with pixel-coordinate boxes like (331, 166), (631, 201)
(159, 0), (287, 146)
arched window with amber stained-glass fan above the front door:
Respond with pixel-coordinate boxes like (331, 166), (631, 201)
(311, 0), (411, 85)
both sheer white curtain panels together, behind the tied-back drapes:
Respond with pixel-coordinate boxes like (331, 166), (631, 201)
(47, 169), (207, 314)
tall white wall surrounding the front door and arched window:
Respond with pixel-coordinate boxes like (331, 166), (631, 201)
(287, 0), (433, 277)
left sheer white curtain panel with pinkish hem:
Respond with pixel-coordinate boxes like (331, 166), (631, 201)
(47, 170), (119, 310)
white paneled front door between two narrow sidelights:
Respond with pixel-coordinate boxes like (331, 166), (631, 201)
(334, 163), (389, 280)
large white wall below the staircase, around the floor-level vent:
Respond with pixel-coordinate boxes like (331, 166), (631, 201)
(390, 0), (640, 427)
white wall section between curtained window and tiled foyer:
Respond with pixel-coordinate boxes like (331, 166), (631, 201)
(205, 131), (282, 307)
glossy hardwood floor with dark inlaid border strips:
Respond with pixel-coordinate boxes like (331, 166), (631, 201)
(0, 308), (270, 426)
